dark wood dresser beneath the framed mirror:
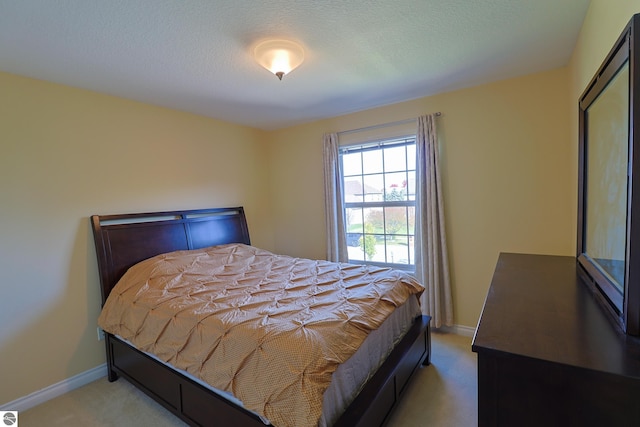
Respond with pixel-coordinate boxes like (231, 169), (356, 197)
(472, 253), (640, 427)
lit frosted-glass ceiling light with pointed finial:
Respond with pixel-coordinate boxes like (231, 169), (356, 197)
(253, 40), (304, 80)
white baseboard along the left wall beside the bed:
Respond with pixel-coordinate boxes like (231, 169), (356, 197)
(0, 363), (107, 411)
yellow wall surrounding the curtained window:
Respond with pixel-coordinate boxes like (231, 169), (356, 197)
(269, 68), (575, 327)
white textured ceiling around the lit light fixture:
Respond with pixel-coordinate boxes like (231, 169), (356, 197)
(0, 0), (589, 129)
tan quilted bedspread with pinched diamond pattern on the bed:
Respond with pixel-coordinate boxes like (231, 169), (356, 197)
(98, 244), (423, 427)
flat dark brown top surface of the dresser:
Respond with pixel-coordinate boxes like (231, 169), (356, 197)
(472, 253), (640, 378)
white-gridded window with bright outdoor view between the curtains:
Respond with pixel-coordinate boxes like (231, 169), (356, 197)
(340, 137), (416, 270)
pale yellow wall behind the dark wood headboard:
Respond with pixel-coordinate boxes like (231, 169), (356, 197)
(0, 73), (272, 404)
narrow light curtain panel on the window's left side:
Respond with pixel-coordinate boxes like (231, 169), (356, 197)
(323, 133), (348, 262)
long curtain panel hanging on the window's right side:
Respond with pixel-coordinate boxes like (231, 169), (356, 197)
(414, 114), (453, 328)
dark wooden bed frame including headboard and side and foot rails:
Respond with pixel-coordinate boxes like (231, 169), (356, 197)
(91, 207), (431, 427)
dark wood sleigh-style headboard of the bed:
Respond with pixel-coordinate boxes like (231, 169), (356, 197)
(91, 207), (251, 304)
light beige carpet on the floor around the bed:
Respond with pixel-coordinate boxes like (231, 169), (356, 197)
(18, 333), (478, 427)
